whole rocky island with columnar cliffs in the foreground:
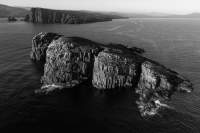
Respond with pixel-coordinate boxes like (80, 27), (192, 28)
(32, 33), (193, 116)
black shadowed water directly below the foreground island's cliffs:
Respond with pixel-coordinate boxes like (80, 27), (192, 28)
(2, 85), (139, 132)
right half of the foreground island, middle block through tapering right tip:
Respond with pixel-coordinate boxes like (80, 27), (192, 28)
(93, 51), (192, 116)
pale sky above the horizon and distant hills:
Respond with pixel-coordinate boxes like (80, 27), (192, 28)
(0, 0), (200, 14)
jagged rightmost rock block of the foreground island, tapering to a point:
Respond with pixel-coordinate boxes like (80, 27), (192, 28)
(136, 61), (192, 116)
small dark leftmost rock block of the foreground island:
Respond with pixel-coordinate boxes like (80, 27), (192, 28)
(30, 33), (61, 61)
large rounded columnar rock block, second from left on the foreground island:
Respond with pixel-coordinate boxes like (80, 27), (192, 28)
(39, 37), (100, 91)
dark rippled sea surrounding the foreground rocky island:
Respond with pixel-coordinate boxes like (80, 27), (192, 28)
(0, 19), (200, 133)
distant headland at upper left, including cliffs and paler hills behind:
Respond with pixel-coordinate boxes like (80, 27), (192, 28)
(0, 4), (128, 24)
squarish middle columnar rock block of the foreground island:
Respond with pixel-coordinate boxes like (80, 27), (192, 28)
(92, 51), (138, 89)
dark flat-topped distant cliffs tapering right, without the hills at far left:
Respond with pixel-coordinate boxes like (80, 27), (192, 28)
(25, 8), (124, 24)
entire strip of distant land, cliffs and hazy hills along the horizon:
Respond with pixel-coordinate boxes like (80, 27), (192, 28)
(0, 4), (200, 24)
